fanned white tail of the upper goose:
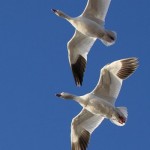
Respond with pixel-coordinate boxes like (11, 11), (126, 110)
(101, 30), (117, 46)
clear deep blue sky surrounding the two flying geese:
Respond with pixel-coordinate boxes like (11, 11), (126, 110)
(0, 0), (150, 150)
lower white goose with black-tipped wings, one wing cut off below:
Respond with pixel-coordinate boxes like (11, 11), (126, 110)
(56, 58), (138, 150)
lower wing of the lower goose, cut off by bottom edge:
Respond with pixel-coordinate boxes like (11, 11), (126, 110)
(71, 109), (104, 150)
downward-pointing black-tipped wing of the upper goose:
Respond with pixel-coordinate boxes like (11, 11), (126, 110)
(67, 30), (96, 86)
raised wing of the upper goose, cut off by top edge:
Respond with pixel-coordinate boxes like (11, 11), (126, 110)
(82, 0), (111, 23)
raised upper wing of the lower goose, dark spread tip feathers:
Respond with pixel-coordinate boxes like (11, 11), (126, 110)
(92, 58), (138, 104)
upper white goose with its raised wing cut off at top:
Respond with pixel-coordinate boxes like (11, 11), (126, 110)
(52, 0), (116, 86)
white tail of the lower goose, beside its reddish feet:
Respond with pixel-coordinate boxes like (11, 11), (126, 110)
(110, 107), (128, 126)
